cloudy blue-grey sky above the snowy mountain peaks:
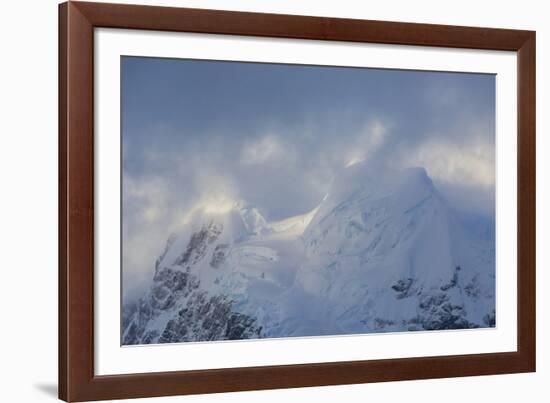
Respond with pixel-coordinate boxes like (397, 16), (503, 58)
(122, 57), (495, 296)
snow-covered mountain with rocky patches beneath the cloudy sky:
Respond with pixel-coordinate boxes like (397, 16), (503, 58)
(122, 163), (495, 344)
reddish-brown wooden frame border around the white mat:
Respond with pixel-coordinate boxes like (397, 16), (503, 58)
(59, 2), (536, 402)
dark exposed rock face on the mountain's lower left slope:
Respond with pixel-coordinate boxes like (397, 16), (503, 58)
(122, 223), (261, 345)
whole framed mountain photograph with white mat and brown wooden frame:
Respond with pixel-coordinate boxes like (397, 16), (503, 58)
(59, 2), (535, 401)
